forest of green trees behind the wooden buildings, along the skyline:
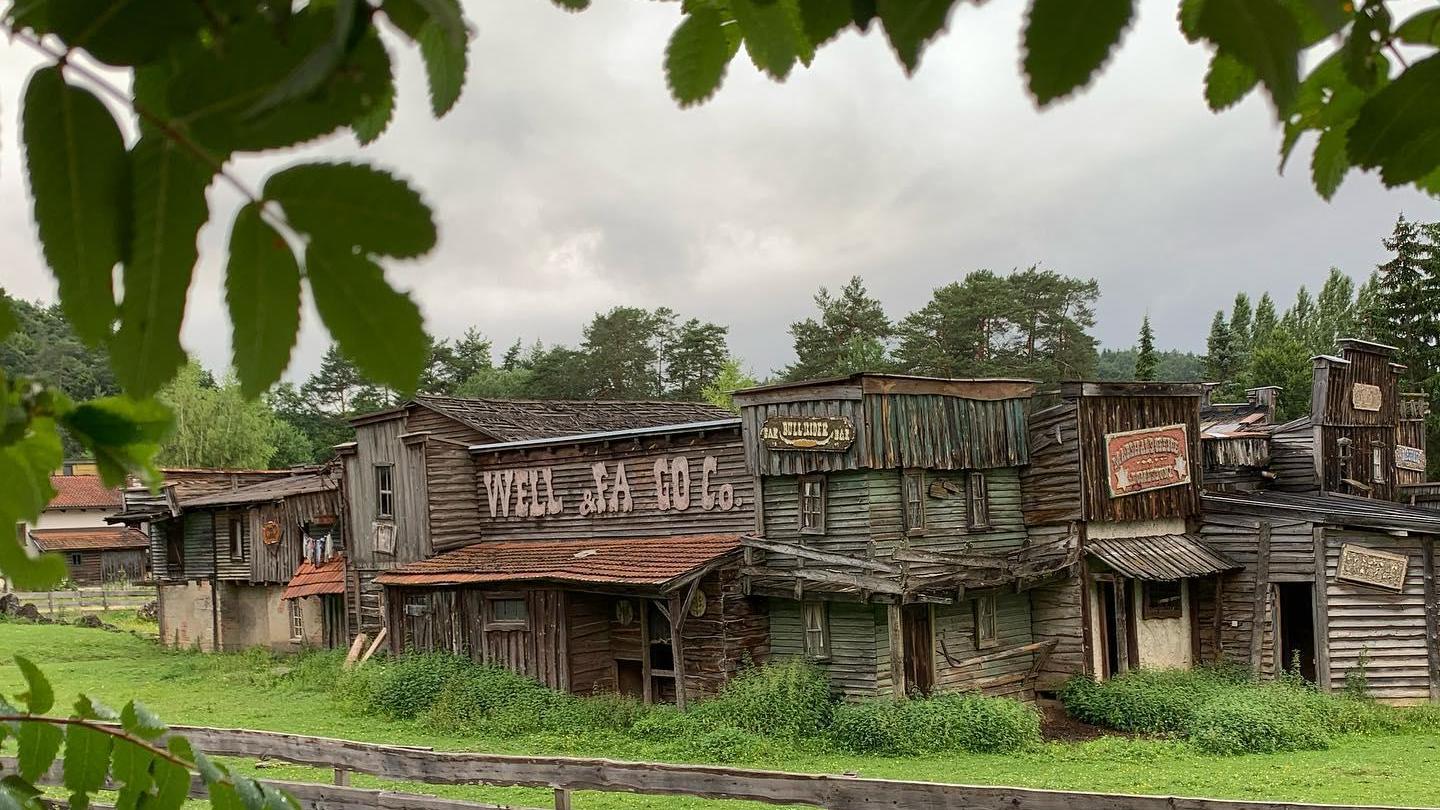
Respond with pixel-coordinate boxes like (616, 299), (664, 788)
(0, 216), (1440, 468)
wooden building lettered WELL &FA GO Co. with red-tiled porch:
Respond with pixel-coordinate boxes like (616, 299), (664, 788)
(376, 418), (766, 705)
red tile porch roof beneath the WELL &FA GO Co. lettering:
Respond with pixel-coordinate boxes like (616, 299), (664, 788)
(376, 535), (740, 587)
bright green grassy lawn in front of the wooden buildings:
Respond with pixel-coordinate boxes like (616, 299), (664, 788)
(0, 613), (1440, 810)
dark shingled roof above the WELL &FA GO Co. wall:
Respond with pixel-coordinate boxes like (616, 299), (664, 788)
(413, 393), (734, 441)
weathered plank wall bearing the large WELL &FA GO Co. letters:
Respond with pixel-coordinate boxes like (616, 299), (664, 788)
(472, 428), (755, 545)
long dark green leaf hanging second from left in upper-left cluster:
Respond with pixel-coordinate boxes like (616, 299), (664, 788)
(109, 137), (213, 396)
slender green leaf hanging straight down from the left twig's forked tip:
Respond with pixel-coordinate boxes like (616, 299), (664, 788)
(225, 203), (300, 398)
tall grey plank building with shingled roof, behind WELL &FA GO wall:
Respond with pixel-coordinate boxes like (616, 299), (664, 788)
(336, 395), (729, 633)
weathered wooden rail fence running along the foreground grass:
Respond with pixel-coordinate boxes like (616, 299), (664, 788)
(19, 726), (1428, 810)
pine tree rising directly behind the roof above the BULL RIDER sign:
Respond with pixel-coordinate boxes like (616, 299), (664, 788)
(785, 275), (894, 380)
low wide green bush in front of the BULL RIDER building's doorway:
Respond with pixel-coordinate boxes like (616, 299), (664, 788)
(831, 695), (1040, 755)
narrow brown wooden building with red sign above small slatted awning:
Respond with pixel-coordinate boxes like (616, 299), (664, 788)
(1022, 382), (1238, 689)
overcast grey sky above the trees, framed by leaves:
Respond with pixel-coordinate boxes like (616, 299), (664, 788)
(0, 0), (1440, 376)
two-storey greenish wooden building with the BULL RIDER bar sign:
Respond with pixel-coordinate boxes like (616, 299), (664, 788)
(736, 373), (1074, 698)
